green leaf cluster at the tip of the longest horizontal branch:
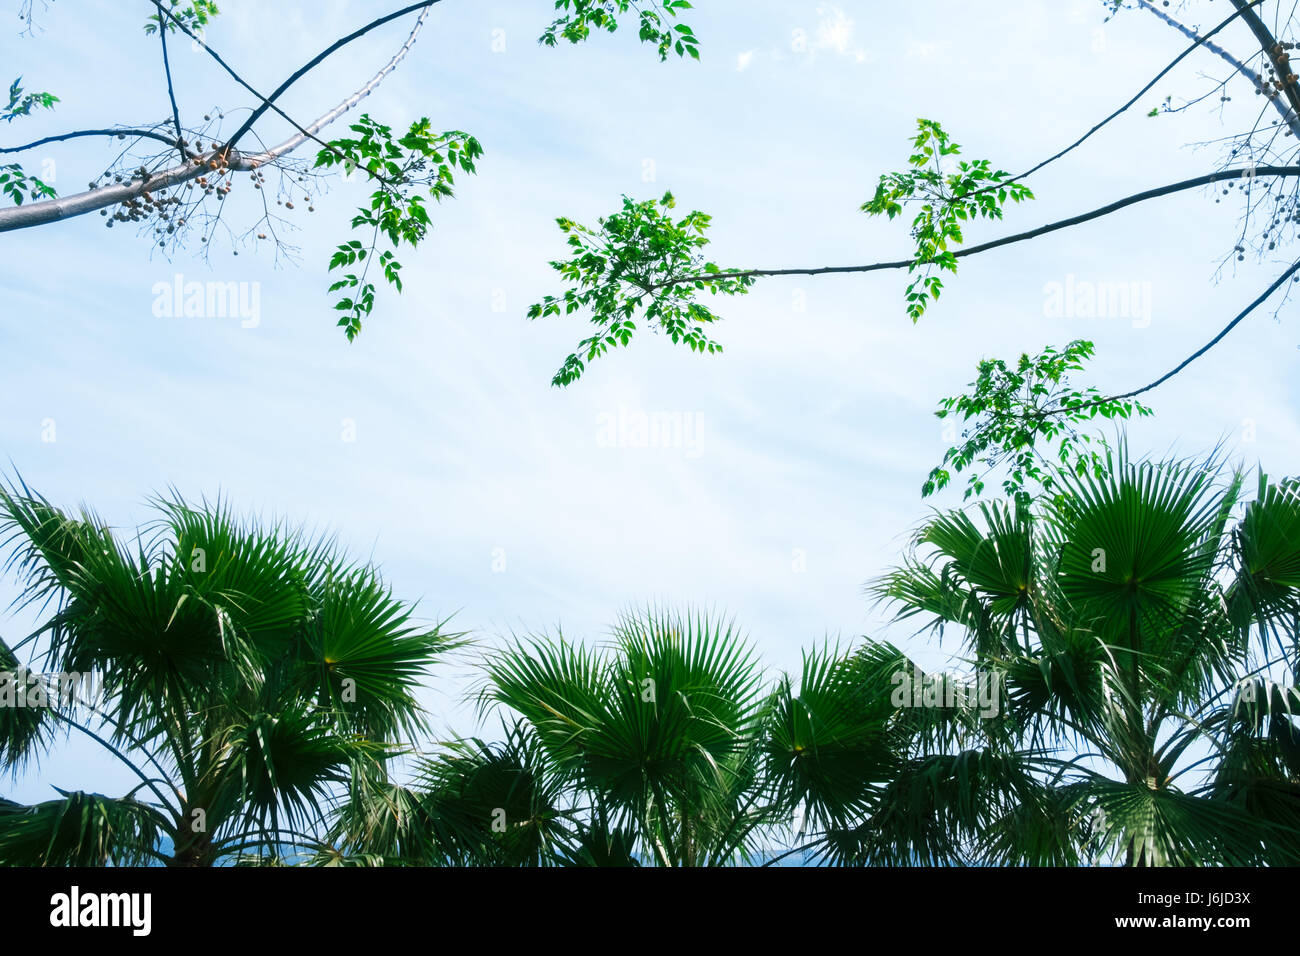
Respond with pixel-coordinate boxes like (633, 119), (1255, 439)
(528, 193), (754, 385)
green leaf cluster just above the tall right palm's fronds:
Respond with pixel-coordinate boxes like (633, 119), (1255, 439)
(920, 339), (1152, 498)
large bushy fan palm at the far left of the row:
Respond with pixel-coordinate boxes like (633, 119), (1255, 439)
(0, 485), (456, 866)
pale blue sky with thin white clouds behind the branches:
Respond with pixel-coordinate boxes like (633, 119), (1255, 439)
(0, 0), (1300, 801)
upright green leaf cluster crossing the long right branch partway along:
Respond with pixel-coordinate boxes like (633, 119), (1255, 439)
(862, 120), (1034, 321)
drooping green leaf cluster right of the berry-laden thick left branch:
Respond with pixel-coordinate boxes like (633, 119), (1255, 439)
(316, 113), (482, 341)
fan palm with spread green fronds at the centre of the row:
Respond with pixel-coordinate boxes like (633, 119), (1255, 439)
(484, 610), (764, 866)
